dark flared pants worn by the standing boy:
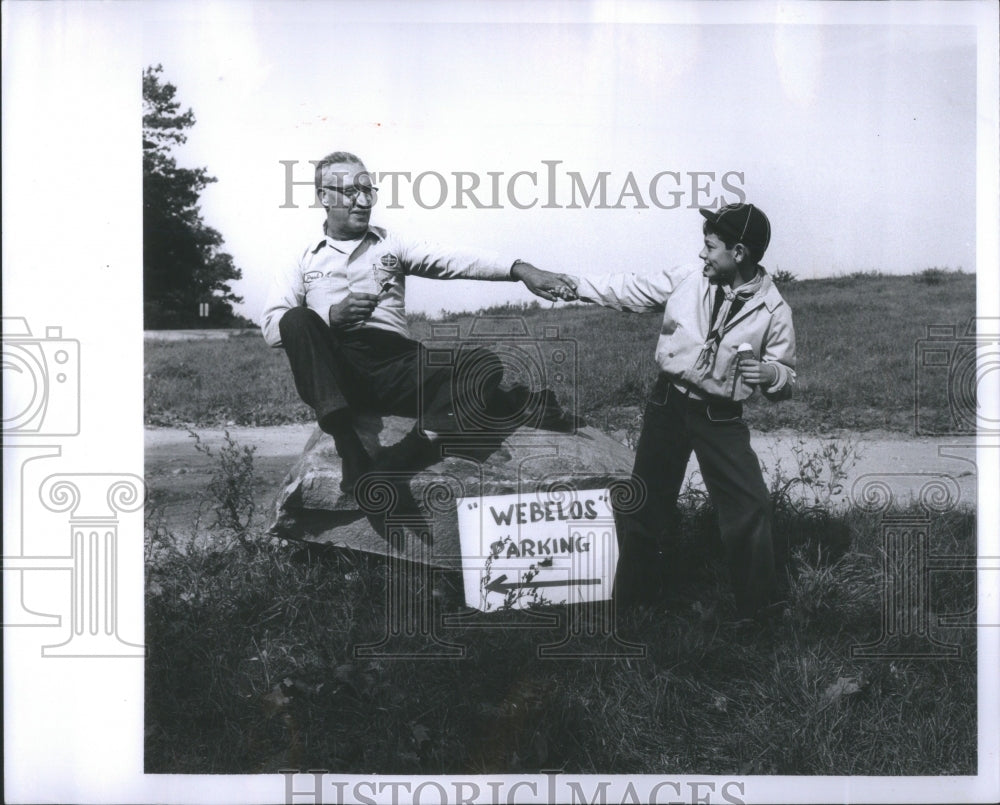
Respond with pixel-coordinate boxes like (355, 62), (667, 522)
(615, 375), (777, 615)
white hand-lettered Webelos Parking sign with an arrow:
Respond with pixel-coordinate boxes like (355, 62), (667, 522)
(458, 489), (618, 612)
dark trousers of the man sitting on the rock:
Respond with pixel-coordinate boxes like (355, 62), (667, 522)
(278, 307), (518, 433)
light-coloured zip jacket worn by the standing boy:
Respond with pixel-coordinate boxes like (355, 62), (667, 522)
(577, 263), (795, 400)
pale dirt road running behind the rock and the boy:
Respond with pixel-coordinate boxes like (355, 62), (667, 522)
(145, 425), (977, 532)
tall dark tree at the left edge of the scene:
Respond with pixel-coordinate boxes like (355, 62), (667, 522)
(142, 64), (245, 329)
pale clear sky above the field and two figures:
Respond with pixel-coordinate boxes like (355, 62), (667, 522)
(142, 3), (976, 318)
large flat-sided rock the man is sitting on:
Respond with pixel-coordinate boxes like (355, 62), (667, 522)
(270, 417), (635, 569)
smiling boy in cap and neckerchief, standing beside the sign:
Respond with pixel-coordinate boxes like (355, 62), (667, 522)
(576, 204), (795, 617)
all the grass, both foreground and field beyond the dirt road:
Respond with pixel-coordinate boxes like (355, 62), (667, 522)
(145, 272), (977, 775)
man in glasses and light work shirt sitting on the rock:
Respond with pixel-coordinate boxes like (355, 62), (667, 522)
(261, 152), (571, 492)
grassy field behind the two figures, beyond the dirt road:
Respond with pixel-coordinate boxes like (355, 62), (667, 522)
(145, 269), (976, 433)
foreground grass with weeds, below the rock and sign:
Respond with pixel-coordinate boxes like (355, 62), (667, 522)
(145, 440), (977, 775)
